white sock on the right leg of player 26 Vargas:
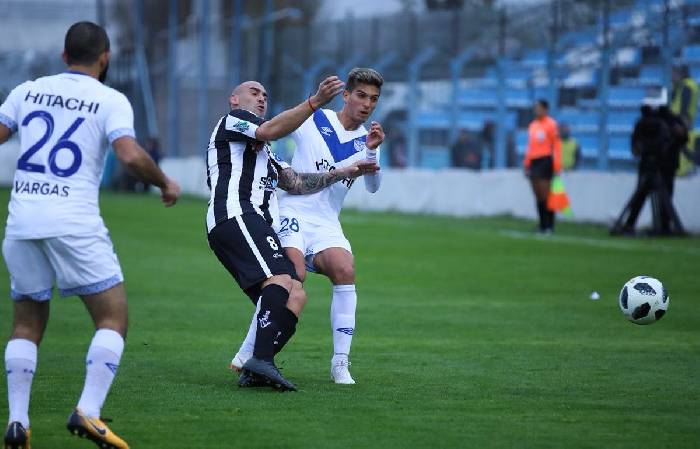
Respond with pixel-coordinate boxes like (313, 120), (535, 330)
(78, 329), (124, 418)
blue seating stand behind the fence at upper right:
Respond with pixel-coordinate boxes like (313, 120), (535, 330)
(412, 0), (700, 168)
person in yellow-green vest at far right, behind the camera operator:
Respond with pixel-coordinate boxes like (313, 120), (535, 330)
(670, 65), (698, 176)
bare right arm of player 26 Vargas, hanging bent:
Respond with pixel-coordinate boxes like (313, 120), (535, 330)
(112, 136), (180, 207)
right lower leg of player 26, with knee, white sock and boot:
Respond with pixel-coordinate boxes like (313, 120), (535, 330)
(66, 283), (129, 449)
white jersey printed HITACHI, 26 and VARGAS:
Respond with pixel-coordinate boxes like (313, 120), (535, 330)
(0, 72), (135, 239)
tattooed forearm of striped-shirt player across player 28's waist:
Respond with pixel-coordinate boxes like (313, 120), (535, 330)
(277, 160), (379, 195)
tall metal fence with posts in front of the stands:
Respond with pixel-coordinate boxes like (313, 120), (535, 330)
(0, 0), (700, 169)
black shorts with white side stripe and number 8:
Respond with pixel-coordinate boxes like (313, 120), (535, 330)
(208, 214), (299, 303)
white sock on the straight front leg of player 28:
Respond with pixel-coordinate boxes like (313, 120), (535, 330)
(331, 284), (357, 360)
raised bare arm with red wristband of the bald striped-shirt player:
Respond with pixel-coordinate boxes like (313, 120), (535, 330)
(255, 76), (345, 141)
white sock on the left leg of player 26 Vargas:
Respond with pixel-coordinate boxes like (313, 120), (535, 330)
(5, 338), (37, 429)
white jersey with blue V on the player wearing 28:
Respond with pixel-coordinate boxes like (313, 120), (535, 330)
(279, 109), (379, 225)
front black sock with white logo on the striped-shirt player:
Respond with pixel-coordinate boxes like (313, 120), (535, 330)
(253, 284), (289, 361)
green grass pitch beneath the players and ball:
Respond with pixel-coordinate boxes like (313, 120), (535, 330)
(0, 190), (700, 449)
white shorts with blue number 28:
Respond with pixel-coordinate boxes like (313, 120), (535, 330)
(275, 215), (352, 273)
